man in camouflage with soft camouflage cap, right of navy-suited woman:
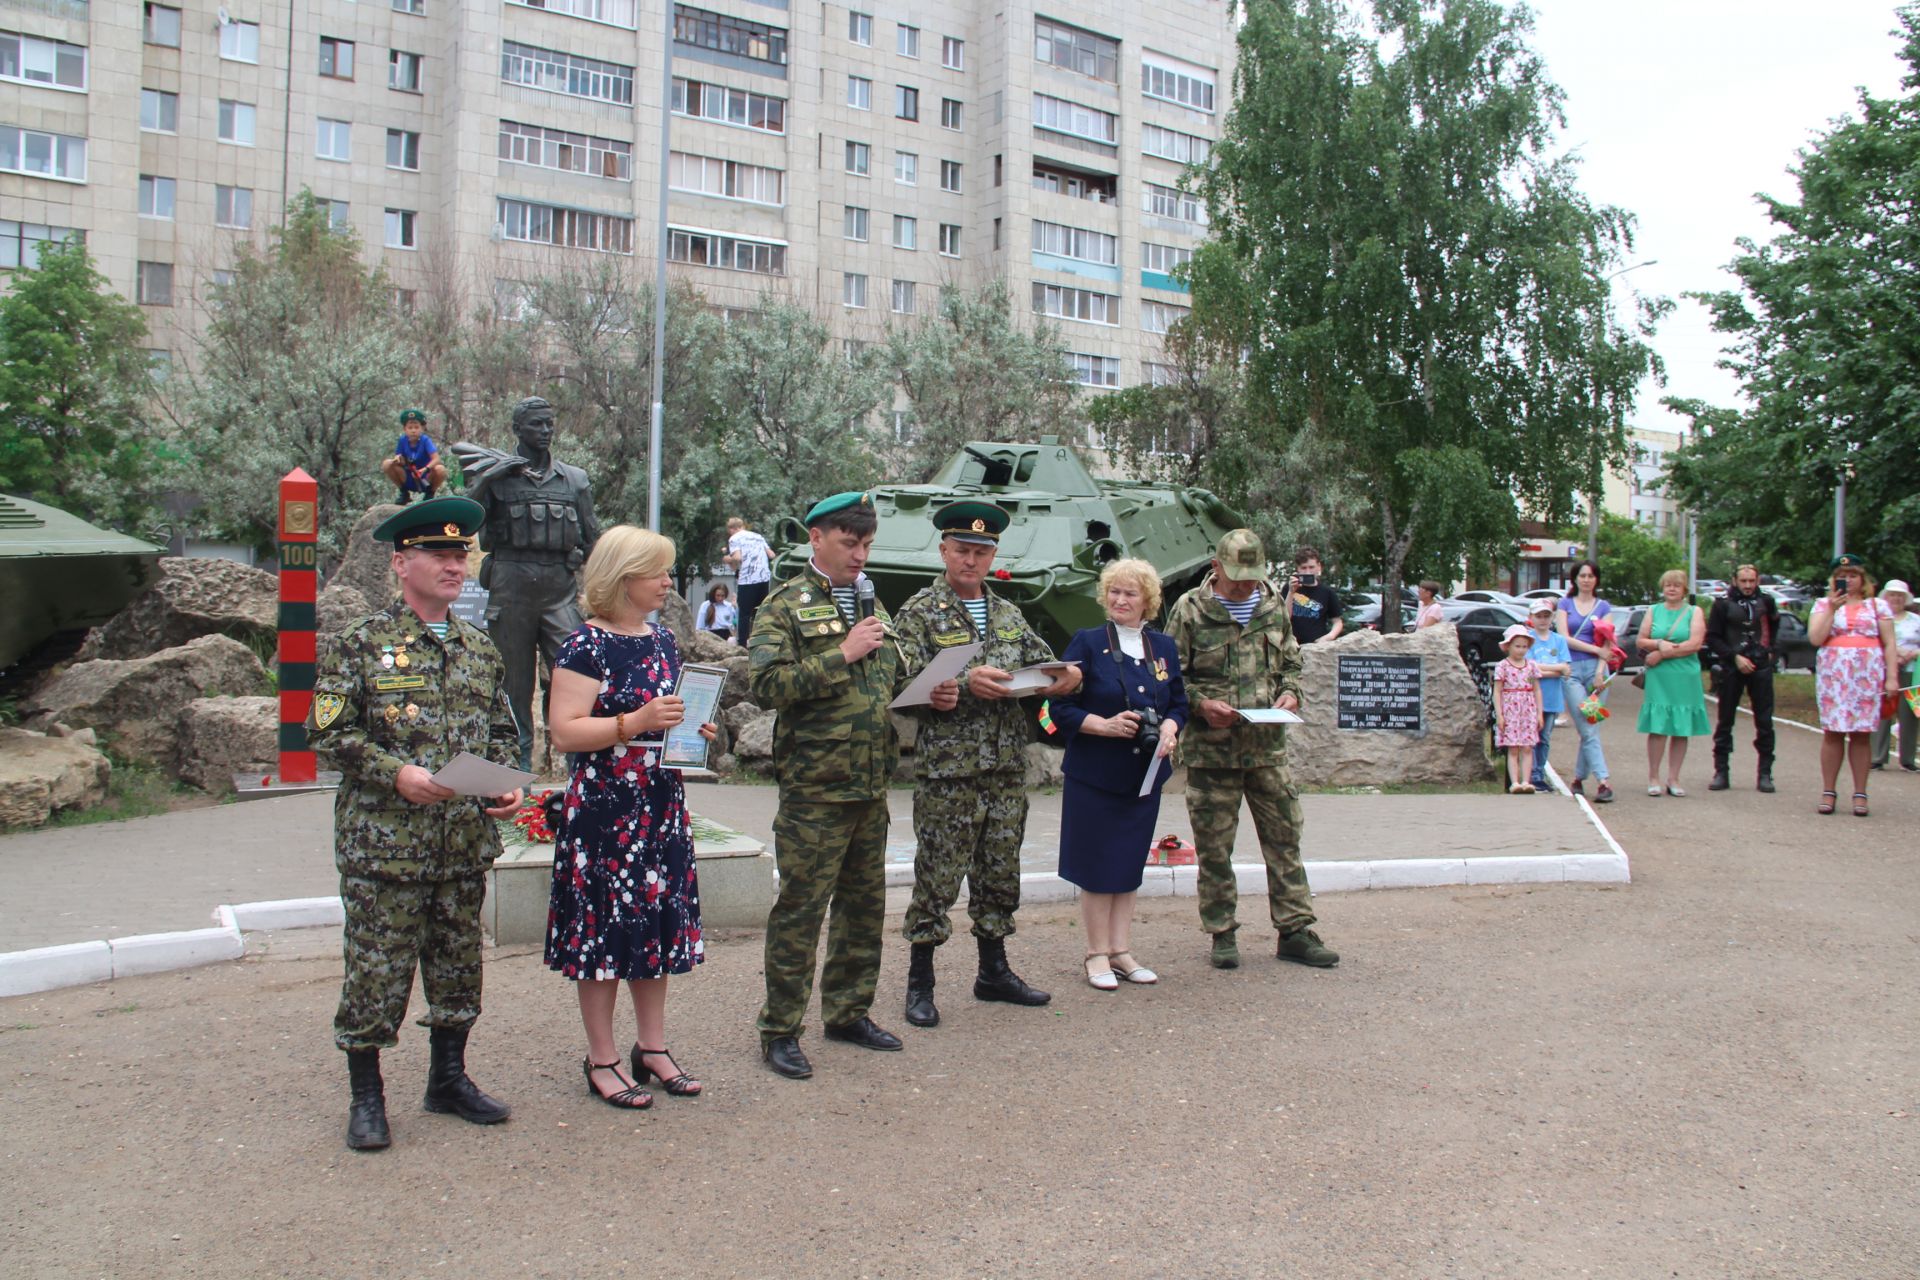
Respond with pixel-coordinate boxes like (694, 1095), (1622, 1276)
(1167, 530), (1340, 969)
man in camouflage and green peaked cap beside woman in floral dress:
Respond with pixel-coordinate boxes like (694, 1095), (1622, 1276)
(307, 497), (520, 1150)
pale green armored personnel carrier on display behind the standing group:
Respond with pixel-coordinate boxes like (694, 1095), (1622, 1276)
(774, 436), (1246, 652)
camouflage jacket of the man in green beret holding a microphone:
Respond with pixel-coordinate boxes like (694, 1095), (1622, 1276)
(747, 564), (904, 802)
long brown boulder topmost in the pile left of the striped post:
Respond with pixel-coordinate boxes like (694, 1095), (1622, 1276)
(79, 557), (280, 662)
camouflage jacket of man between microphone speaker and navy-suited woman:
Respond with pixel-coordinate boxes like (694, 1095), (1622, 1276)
(895, 578), (1054, 777)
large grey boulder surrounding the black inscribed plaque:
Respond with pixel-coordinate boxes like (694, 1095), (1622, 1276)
(1286, 624), (1488, 787)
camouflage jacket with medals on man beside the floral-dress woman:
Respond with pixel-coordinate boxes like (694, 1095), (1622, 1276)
(307, 601), (518, 881)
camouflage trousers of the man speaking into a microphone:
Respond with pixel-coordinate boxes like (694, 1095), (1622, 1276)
(756, 796), (887, 1042)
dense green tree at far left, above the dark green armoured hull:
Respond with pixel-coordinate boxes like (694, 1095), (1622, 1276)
(0, 238), (154, 530)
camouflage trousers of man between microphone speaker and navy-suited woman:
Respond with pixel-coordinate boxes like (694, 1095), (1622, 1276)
(904, 773), (1027, 944)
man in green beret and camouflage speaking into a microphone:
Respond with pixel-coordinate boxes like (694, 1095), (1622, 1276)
(749, 493), (904, 1080)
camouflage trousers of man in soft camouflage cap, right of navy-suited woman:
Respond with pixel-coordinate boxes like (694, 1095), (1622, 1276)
(1187, 764), (1313, 935)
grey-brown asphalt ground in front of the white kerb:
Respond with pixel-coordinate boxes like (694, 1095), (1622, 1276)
(0, 691), (1920, 1280)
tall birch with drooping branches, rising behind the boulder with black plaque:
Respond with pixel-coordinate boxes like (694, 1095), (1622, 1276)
(1192, 0), (1665, 626)
